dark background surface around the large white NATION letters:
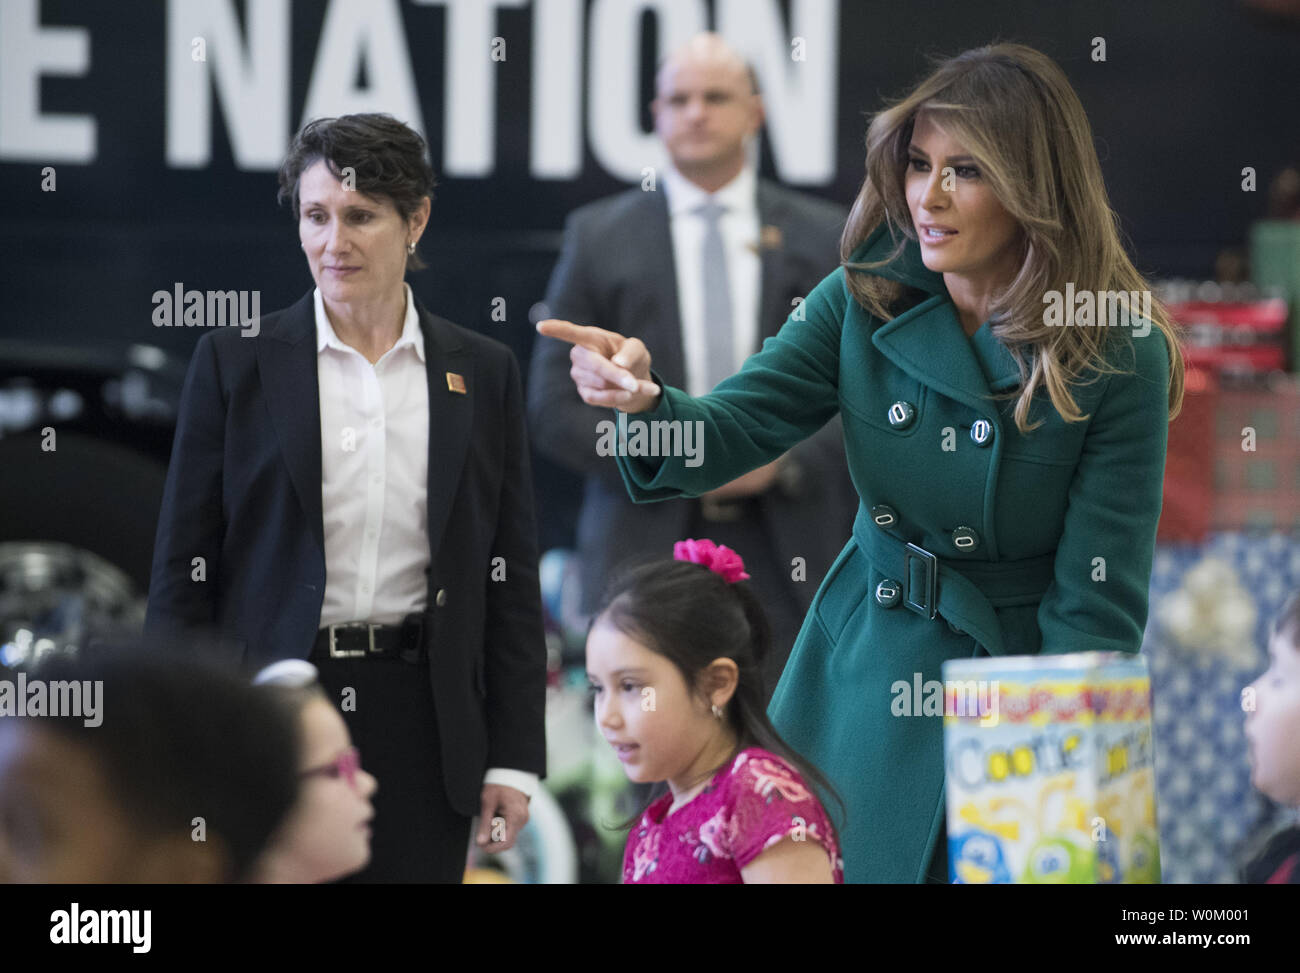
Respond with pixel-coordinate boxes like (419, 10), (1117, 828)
(0, 0), (1300, 544)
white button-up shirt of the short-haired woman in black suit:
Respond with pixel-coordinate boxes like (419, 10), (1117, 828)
(313, 285), (538, 796)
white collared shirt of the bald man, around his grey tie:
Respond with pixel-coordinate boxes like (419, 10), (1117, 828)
(663, 165), (762, 395)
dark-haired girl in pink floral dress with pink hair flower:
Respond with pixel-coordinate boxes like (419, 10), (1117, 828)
(586, 540), (844, 885)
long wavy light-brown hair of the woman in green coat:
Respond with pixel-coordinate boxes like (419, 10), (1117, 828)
(840, 44), (1183, 433)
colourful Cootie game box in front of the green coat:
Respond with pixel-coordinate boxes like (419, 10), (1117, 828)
(943, 652), (1160, 885)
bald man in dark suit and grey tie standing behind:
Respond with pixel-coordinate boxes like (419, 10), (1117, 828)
(529, 34), (857, 693)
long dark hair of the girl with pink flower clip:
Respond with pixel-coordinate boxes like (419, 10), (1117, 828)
(593, 561), (848, 827)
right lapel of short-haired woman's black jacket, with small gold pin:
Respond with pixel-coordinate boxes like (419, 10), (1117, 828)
(416, 300), (476, 561)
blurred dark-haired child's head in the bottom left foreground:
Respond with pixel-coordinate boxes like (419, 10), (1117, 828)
(0, 644), (299, 885)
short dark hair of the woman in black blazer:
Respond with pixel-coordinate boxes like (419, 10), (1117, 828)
(276, 112), (436, 271)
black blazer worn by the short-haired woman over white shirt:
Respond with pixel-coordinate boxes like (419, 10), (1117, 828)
(147, 293), (546, 816)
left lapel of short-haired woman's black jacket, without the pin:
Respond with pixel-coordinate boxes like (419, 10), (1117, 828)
(256, 291), (325, 557)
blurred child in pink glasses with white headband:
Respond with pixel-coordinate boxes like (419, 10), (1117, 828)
(254, 660), (378, 885)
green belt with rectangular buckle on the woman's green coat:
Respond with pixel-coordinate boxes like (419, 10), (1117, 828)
(853, 506), (1056, 656)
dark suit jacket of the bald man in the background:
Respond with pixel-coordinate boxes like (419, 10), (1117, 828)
(528, 180), (858, 611)
